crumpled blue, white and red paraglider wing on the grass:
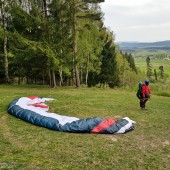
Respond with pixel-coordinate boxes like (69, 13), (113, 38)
(8, 96), (135, 134)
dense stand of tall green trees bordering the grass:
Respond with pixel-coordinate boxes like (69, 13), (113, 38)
(0, 0), (137, 87)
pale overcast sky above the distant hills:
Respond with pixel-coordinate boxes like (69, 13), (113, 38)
(101, 0), (170, 42)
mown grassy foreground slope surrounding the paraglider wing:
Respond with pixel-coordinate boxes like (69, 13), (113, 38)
(0, 85), (170, 170)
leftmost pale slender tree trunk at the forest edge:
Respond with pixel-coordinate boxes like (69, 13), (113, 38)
(4, 34), (9, 83)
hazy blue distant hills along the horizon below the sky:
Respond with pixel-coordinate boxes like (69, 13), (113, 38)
(117, 40), (170, 52)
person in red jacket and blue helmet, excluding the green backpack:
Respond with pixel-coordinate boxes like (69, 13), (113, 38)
(140, 80), (151, 109)
